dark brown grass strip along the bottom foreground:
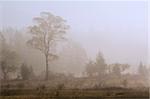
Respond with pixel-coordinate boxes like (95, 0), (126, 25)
(0, 88), (149, 99)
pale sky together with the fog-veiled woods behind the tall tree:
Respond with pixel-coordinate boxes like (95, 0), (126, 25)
(0, 1), (148, 79)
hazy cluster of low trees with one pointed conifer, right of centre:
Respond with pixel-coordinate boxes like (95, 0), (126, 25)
(86, 52), (130, 77)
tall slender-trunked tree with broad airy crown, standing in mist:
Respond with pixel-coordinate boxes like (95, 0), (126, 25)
(27, 12), (69, 80)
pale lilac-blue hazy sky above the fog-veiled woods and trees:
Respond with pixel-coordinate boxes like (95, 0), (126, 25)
(0, 1), (148, 68)
